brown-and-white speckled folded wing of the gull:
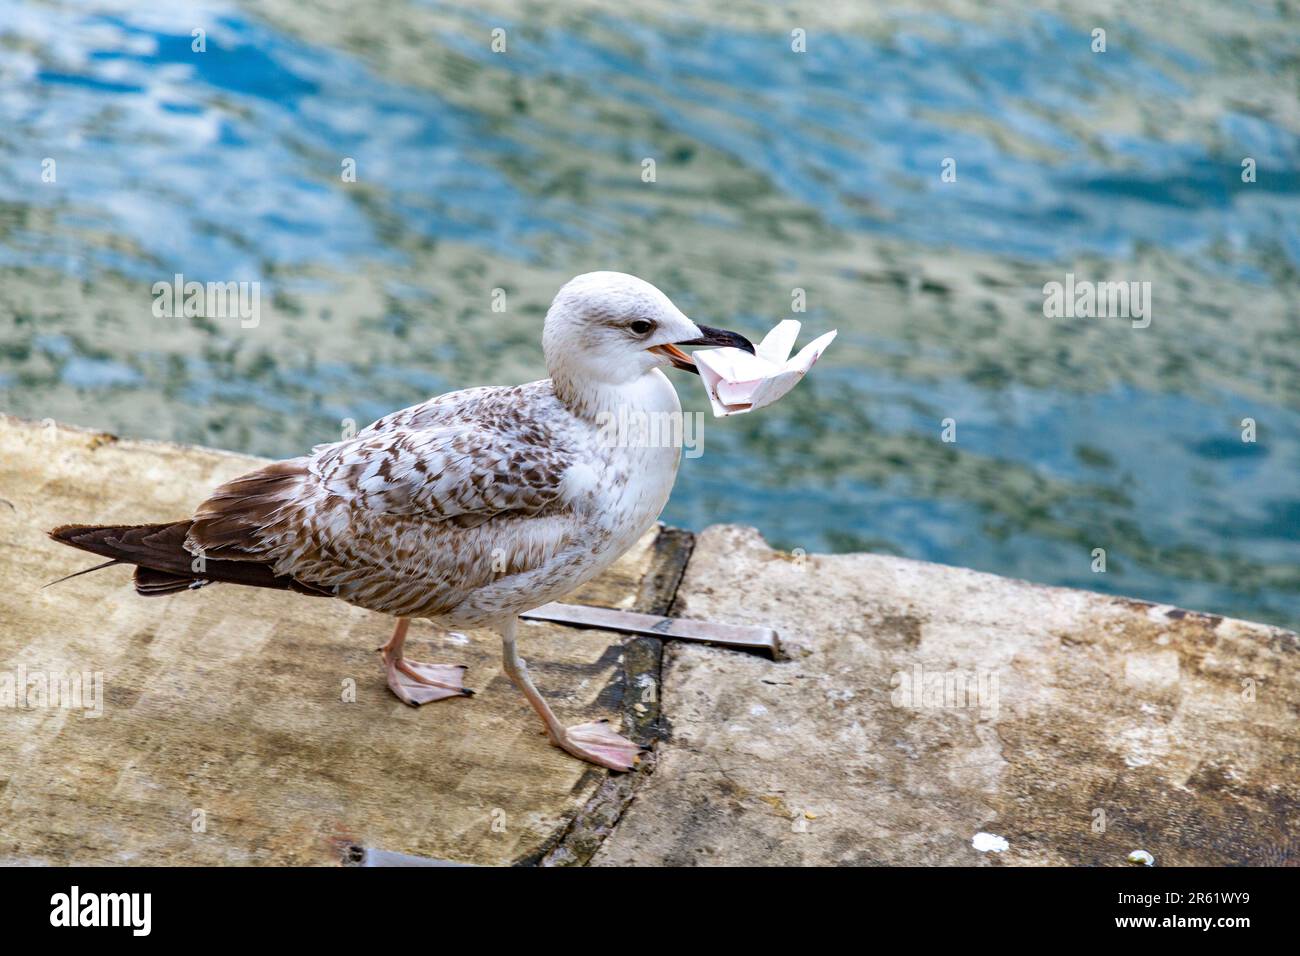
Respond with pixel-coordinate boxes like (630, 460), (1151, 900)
(187, 382), (573, 614)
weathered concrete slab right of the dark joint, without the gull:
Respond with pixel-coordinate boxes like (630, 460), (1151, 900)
(594, 527), (1300, 865)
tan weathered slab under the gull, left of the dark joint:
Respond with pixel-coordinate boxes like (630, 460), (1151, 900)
(0, 419), (676, 864)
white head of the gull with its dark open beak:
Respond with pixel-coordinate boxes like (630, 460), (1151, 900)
(542, 272), (754, 385)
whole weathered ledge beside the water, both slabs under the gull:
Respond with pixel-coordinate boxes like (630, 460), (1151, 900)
(0, 419), (1300, 865)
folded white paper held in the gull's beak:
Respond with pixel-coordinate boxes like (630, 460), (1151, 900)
(692, 319), (835, 419)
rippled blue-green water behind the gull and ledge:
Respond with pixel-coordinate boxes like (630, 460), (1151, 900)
(0, 0), (1300, 627)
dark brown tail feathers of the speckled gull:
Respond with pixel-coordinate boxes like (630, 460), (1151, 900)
(49, 522), (333, 597)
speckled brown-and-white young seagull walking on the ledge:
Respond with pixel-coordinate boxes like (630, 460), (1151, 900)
(49, 272), (754, 771)
